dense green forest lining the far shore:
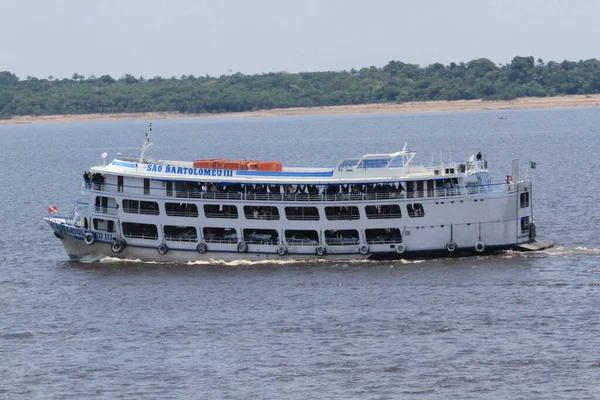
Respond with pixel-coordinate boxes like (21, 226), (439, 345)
(0, 56), (600, 119)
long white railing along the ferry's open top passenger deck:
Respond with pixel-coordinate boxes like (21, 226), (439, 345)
(82, 180), (531, 203)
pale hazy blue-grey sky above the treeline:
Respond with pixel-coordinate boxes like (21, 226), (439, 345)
(0, 0), (600, 78)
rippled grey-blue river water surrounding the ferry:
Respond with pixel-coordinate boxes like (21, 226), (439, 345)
(0, 108), (600, 399)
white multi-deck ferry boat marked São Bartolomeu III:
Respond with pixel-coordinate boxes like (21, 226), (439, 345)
(44, 125), (549, 261)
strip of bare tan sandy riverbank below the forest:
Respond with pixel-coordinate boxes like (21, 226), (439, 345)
(0, 95), (600, 124)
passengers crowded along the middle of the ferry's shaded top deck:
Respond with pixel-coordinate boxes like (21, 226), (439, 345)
(184, 182), (412, 195)
